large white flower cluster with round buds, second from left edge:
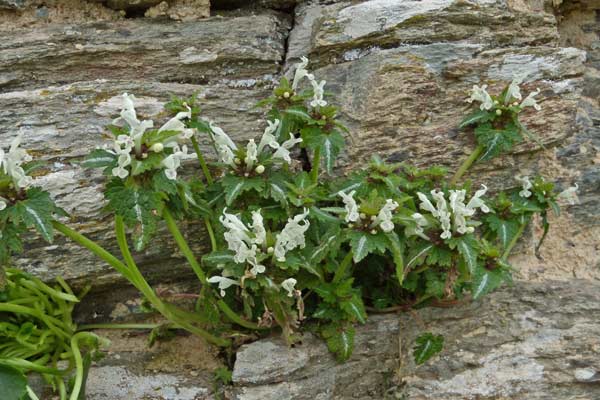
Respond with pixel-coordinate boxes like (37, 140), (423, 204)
(107, 93), (194, 180)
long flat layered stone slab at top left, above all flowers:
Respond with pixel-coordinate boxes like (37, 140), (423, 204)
(0, 14), (288, 91)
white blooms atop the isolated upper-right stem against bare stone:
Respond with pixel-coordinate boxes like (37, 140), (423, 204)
(467, 78), (542, 115)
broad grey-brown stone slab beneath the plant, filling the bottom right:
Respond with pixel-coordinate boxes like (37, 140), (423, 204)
(233, 281), (600, 400)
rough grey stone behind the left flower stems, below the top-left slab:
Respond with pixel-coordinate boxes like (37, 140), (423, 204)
(0, 80), (269, 287)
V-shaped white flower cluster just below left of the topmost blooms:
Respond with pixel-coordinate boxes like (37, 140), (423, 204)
(209, 119), (302, 176)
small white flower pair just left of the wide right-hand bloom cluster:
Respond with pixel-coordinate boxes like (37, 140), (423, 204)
(338, 190), (399, 234)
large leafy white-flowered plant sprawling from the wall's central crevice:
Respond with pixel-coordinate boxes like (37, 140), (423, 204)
(2, 59), (574, 380)
